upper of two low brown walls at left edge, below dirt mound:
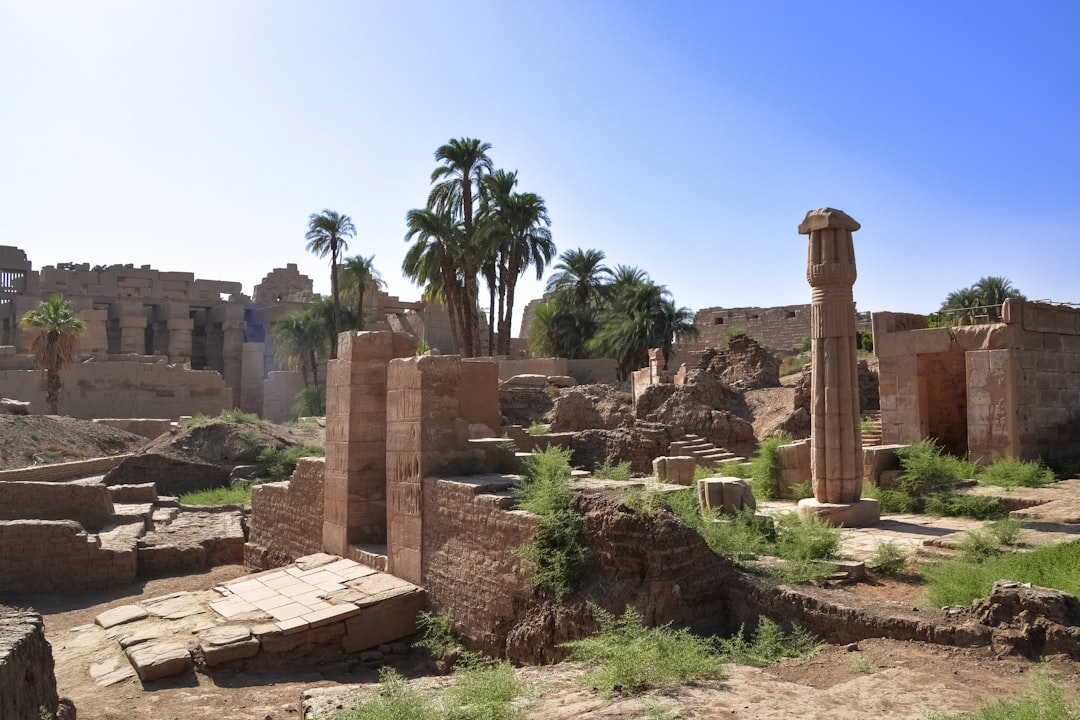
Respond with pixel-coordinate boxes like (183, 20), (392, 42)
(0, 480), (112, 532)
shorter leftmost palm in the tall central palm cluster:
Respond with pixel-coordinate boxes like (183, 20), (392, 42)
(402, 209), (467, 350)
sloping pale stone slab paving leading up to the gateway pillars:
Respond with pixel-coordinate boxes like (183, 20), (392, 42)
(86, 553), (424, 684)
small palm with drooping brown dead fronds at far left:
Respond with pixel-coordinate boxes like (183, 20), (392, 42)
(18, 295), (86, 415)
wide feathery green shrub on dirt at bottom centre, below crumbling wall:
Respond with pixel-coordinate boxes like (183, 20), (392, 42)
(565, 606), (723, 696)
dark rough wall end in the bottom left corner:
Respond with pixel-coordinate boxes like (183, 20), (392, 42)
(0, 606), (59, 720)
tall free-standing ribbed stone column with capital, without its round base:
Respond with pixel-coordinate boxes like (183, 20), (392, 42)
(799, 207), (863, 503)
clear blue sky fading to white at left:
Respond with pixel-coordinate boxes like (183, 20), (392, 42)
(0, 0), (1080, 321)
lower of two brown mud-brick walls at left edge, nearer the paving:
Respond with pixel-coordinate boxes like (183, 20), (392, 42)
(0, 520), (136, 595)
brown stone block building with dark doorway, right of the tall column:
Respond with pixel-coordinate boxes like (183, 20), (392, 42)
(874, 299), (1080, 461)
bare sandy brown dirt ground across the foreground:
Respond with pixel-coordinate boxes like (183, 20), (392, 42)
(6, 566), (1080, 720)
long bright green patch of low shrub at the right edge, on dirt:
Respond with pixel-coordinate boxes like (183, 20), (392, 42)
(922, 541), (1080, 607)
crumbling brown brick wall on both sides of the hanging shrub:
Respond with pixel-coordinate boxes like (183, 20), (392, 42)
(421, 476), (734, 662)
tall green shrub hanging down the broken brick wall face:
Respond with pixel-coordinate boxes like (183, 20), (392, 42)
(511, 447), (589, 599)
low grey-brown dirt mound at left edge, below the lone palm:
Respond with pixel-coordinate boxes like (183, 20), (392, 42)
(0, 415), (147, 470)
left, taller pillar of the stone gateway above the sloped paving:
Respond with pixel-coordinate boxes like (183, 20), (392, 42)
(323, 332), (416, 557)
